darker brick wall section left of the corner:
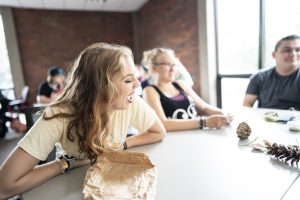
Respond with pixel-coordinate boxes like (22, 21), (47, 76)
(13, 9), (133, 103)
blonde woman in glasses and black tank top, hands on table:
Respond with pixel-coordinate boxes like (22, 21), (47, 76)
(143, 48), (232, 131)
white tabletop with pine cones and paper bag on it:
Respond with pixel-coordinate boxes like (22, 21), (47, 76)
(22, 108), (300, 200)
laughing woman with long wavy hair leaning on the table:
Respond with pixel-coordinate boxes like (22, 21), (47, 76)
(0, 43), (166, 199)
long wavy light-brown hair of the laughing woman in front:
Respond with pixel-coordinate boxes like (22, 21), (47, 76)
(43, 43), (132, 163)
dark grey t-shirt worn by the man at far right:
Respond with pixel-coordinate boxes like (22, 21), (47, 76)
(246, 67), (300, 110)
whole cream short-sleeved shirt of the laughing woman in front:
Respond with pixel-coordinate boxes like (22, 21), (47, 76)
(18, 96), (157, 160)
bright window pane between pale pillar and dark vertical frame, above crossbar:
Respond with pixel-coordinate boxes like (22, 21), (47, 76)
(217, 0), (259, 74)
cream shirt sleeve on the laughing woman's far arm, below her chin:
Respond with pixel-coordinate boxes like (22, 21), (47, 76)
(130, 96), (158, 133)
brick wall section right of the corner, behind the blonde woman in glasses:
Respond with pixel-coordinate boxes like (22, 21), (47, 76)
(134, 0), (200, 94)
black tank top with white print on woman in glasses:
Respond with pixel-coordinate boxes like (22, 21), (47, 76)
(151, 82), (197, 119)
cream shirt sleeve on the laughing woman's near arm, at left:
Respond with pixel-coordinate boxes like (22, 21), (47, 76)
(18, 108), (64, 160)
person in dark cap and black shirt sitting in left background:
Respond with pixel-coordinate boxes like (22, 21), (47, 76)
(36, 66), (65, 104)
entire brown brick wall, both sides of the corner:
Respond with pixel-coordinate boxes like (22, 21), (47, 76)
(12, 0), (200, 103)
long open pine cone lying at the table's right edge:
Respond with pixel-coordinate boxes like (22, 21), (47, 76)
(265, 142), (300, 165)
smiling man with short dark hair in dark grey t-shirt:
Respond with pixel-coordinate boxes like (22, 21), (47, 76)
(243, 35), (300, 110)
